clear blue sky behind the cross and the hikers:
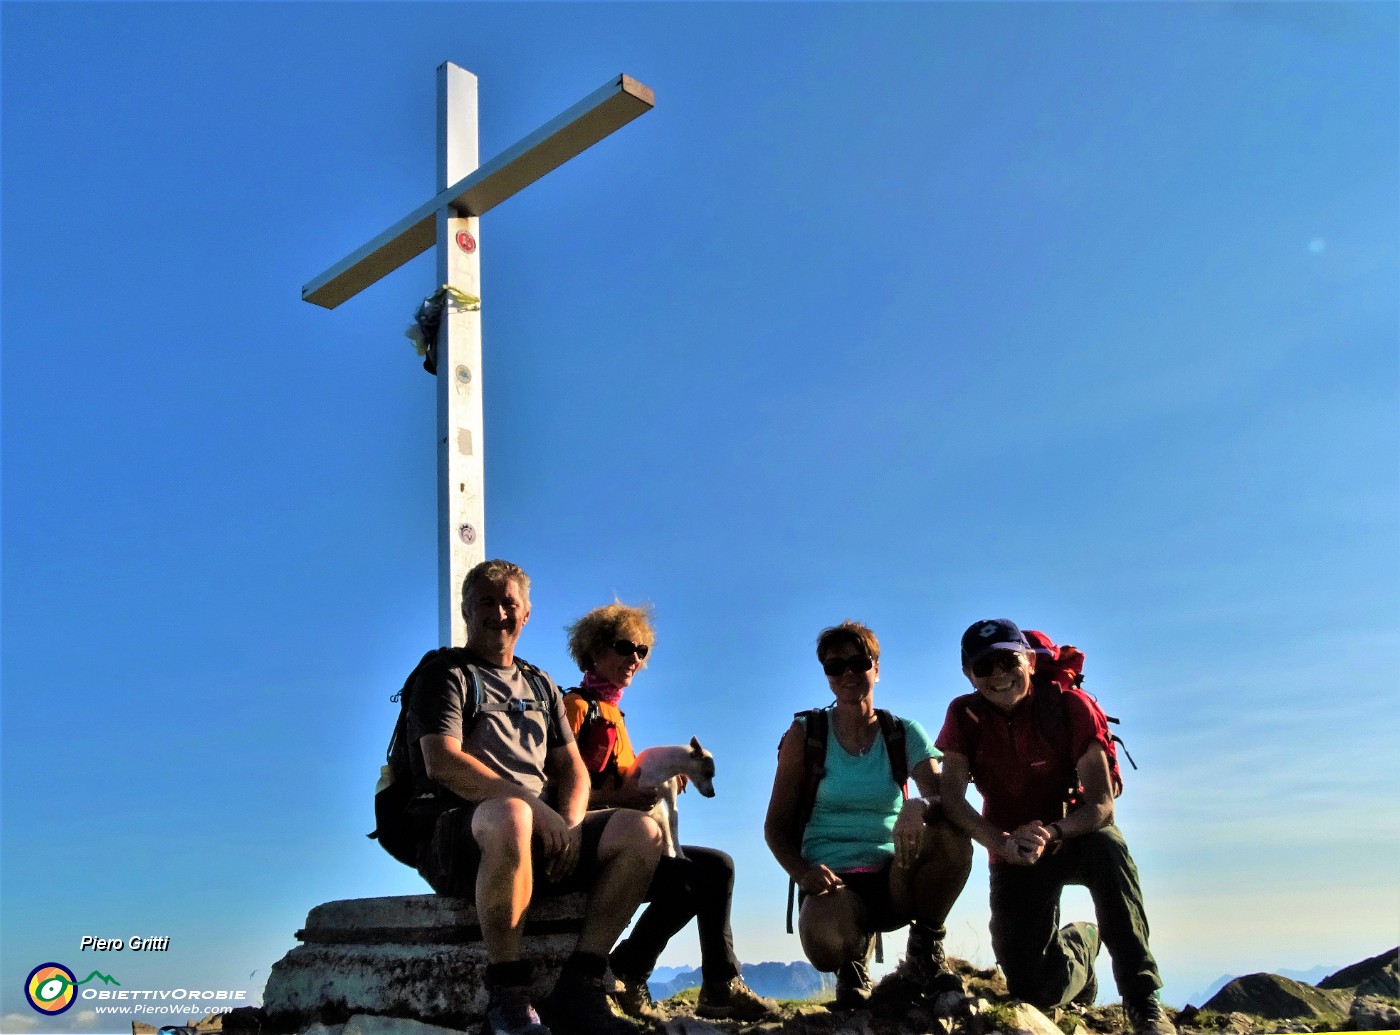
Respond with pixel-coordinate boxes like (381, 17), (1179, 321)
(0, 3), (1400, 1032)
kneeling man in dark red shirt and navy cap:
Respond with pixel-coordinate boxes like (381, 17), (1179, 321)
(935, 618), (1176, 1035)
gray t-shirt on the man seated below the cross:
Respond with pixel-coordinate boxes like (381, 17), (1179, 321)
(407, 647), (574, 794)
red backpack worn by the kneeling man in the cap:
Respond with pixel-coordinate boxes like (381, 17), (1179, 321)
(959, 629), (1137, 808)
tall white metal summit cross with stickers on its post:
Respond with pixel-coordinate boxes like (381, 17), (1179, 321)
(301, 62), (655, 646)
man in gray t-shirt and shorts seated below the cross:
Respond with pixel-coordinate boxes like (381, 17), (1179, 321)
(407, 560), (661, 1035)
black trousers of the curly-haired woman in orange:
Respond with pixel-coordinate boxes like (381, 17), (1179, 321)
(612, 845), (739, 985)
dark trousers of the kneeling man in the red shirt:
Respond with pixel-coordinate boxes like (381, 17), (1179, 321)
(991, 825), (1162, 1008)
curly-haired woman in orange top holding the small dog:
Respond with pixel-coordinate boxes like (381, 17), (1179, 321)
(564, 602), (777, 1021)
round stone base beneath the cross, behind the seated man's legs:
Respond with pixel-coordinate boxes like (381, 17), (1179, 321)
(263, 895), (587, 1032)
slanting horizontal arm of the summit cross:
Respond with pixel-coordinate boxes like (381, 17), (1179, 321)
(301, 76), (655, 310)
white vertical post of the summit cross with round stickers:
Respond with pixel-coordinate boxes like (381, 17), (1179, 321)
(437, 62), (486, 646)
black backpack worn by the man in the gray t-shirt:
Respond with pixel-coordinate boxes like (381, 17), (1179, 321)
(365, 647), (559, 867)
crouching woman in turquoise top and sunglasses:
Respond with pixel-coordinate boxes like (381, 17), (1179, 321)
(764, 622), (972, 1010)
